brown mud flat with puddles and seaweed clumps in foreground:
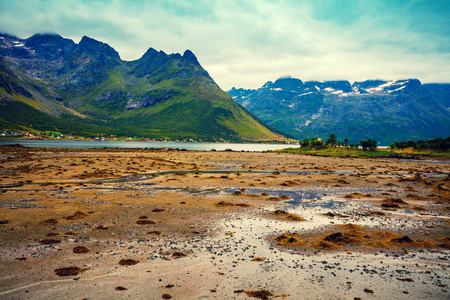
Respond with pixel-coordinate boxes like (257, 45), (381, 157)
(0, 146), (450, 299)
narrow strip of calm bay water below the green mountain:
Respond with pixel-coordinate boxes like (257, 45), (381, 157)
(0, 140), (298, 152)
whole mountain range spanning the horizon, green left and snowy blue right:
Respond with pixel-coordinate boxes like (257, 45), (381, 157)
(0, 34), (450, 145)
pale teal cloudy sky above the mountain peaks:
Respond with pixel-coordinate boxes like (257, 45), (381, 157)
(0, 0), (450, 90)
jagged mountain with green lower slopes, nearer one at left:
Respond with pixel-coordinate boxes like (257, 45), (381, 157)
(0, 34), (284, 141)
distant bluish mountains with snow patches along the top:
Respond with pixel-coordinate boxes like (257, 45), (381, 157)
(228, 77), (450, 145)
